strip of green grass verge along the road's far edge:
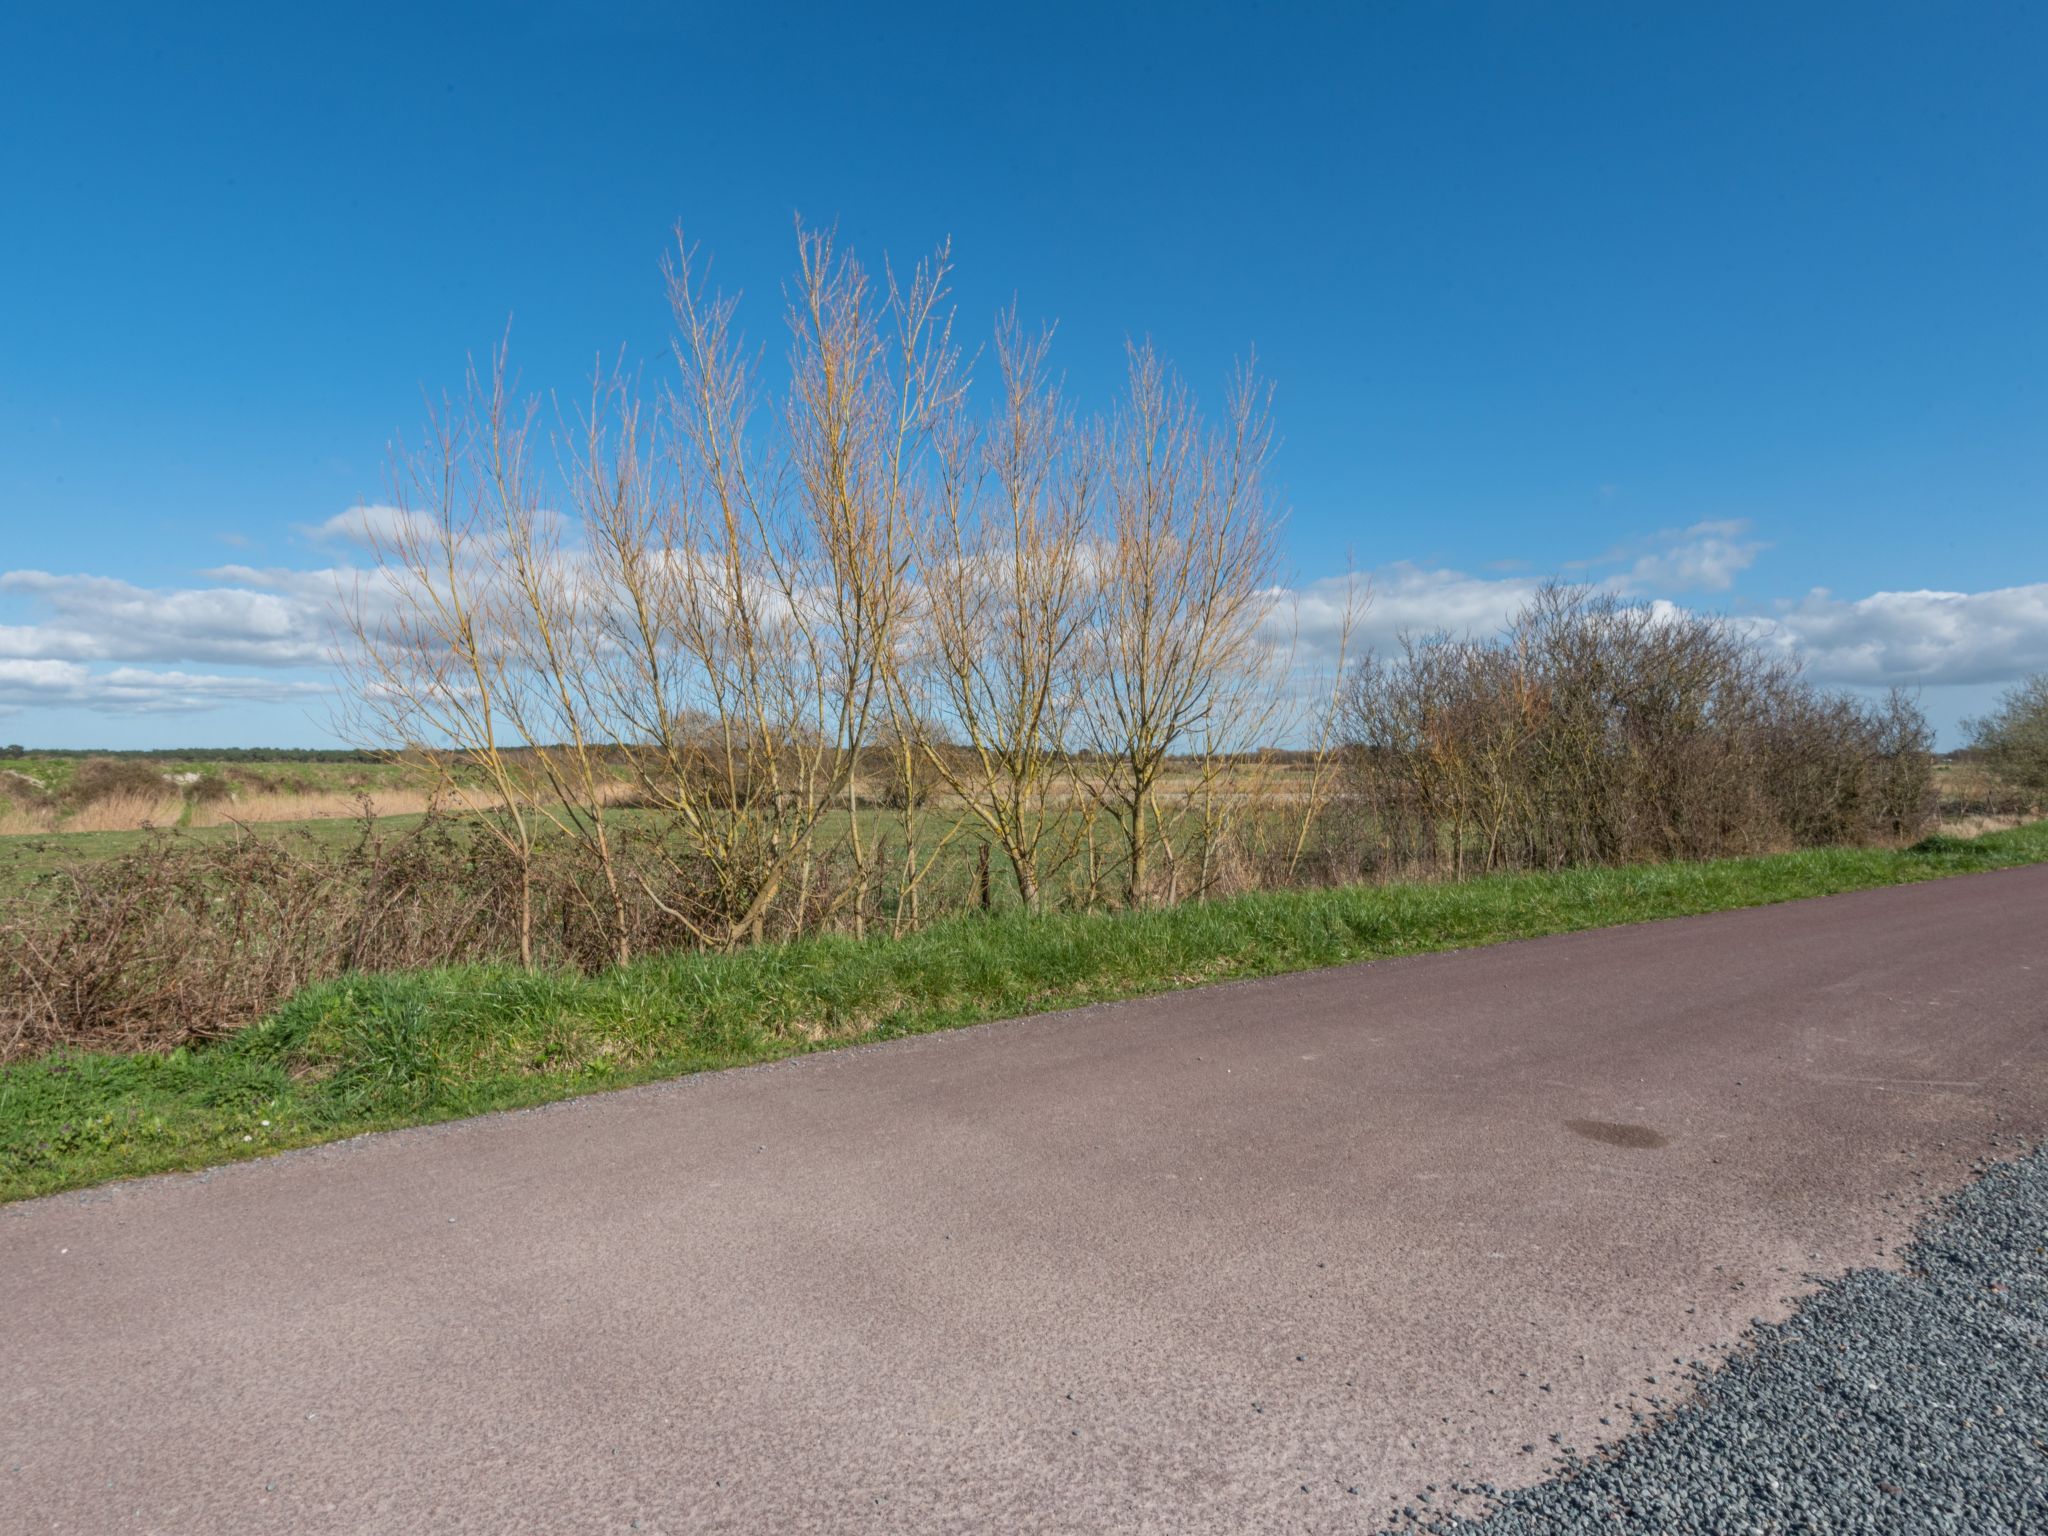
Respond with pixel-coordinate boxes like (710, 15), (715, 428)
(0, 823), (2048, 1200)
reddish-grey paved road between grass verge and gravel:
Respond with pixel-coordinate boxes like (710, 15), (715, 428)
(12, 868), (2048, 1536)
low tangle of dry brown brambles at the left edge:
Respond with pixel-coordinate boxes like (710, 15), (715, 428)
(0, 815), (720, 1061)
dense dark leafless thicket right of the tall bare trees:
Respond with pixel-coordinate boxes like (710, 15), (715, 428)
(1346, 586), (1931, 874)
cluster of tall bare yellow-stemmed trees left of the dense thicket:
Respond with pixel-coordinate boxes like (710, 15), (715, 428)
(348, 231), (1331, 958)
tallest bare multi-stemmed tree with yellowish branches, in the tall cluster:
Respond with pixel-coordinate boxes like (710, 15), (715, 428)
(569, 229), (958, 946)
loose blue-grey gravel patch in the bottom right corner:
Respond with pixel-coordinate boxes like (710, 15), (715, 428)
(1395, 1147), (2048, 1536)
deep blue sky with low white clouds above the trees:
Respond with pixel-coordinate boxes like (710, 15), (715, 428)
(0, 4), (2048, 745)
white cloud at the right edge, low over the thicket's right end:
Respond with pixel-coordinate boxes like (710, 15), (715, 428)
(1759, 582), (2048, 688)
